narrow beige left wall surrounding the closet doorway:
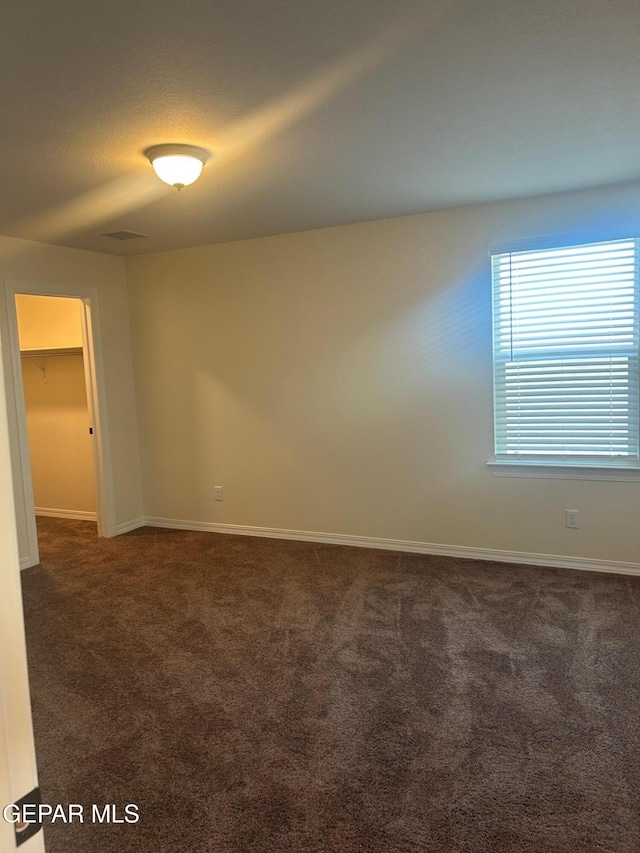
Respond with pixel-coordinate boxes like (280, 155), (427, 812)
(0, 237), (142, 556)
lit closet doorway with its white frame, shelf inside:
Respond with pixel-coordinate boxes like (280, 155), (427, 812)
(5, 282), (115, 568)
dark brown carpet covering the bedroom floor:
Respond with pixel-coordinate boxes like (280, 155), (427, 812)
(18, 519), (640, 853)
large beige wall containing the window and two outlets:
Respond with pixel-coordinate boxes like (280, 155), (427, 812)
(127, 185), (640, 562)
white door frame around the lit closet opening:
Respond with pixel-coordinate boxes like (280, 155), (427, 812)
(5, 280), (116, 568)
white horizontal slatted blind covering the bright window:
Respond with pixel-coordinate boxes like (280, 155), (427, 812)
(492, 239), (639, 466)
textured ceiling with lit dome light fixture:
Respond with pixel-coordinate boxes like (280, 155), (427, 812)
(0, 0), (640, 254)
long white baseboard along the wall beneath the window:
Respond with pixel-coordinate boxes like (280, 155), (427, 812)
(145, 518), (640, 575)
